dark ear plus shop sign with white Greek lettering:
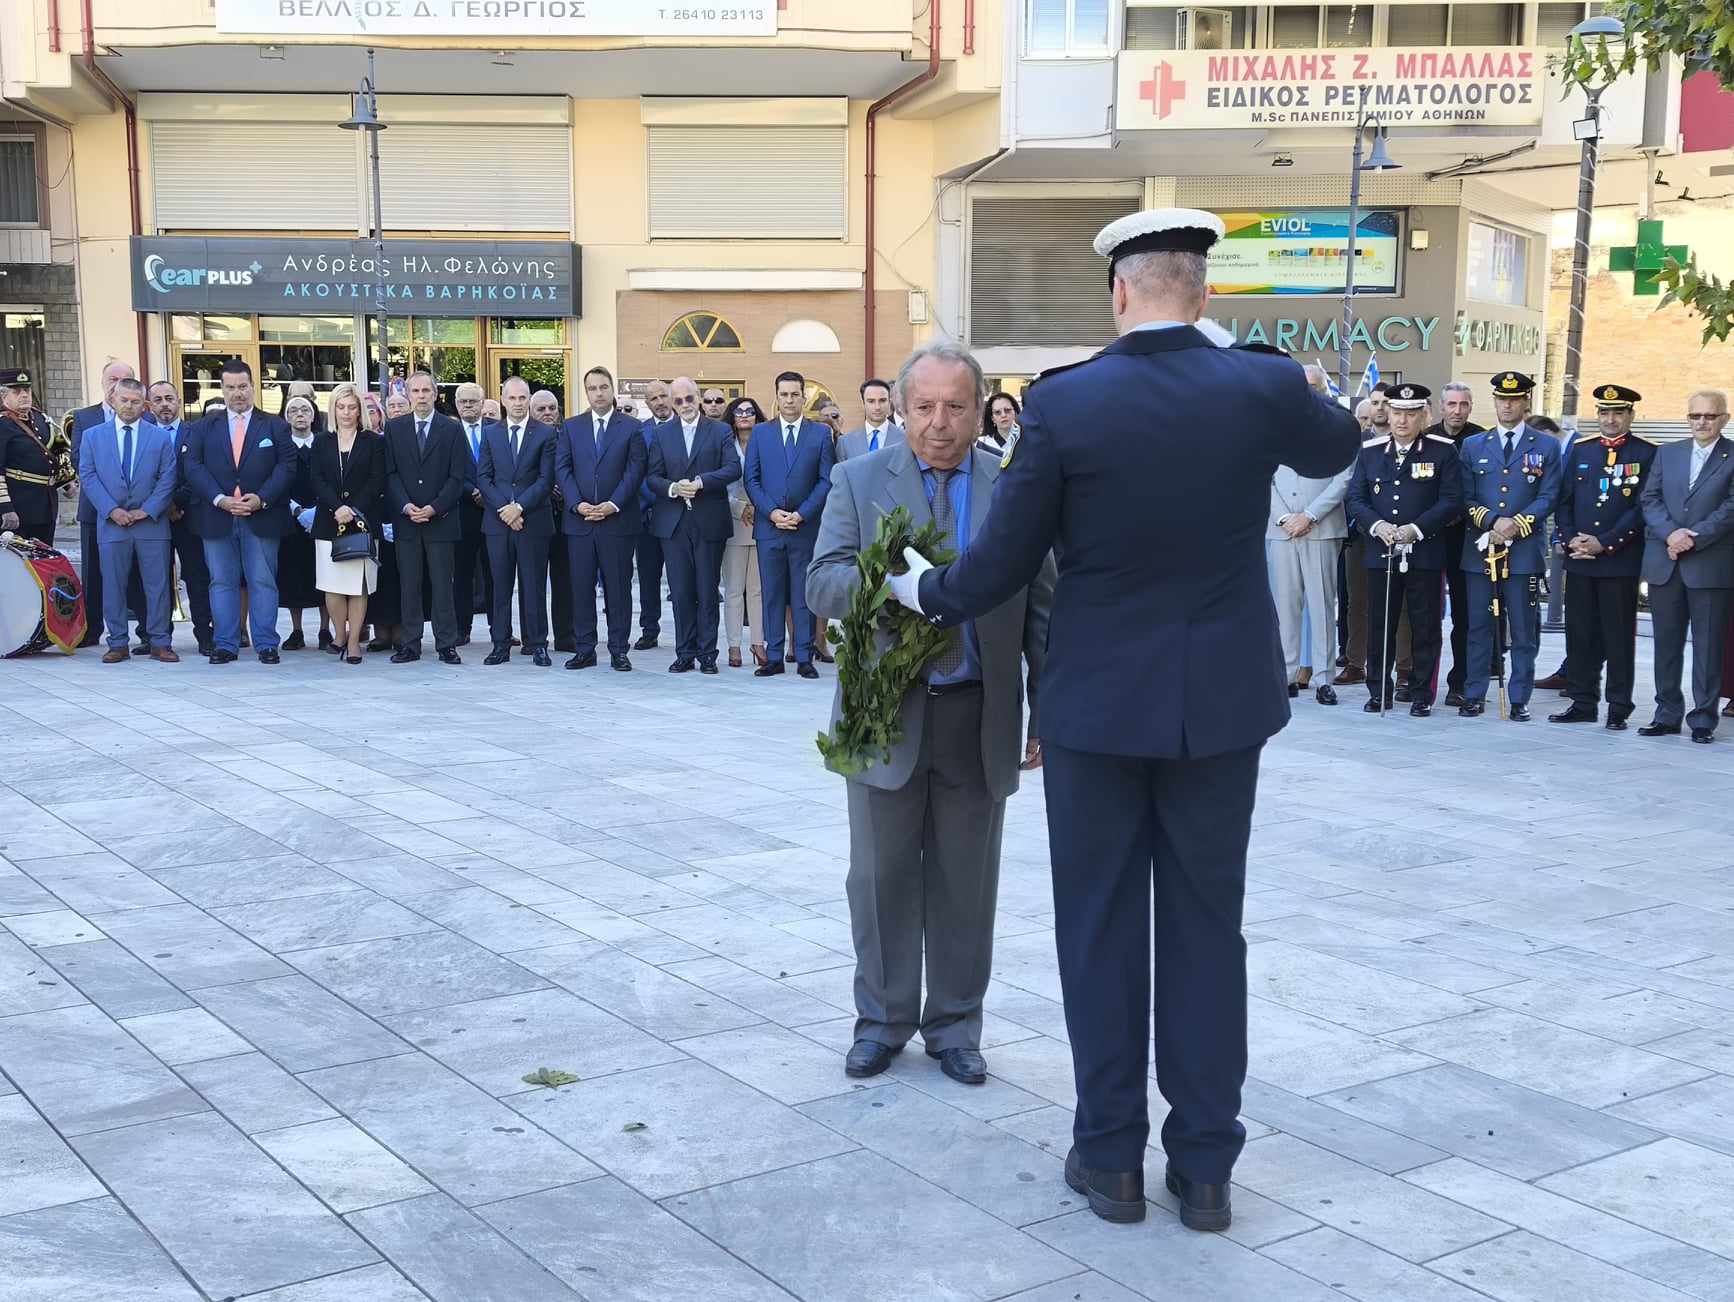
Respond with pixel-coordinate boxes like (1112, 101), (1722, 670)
(132, 236), (583, 317)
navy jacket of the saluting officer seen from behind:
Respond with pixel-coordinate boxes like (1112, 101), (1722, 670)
(915, 326), (1359, 758)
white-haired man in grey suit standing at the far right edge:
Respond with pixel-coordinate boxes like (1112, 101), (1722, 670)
(1637, 388), (1734, 744)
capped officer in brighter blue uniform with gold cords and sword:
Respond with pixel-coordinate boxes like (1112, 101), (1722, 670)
(1457, 371), (1569, 723)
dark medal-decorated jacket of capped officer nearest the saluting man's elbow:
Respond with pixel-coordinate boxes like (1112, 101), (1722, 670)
(1344, 433), (1463, 570)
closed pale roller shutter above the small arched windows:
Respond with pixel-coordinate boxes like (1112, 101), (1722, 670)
(645, 127), (850, 239)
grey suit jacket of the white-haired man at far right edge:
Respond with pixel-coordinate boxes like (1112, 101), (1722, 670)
(1639, 437), (1734, 588)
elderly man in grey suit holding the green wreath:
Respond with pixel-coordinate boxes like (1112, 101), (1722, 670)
(806, 342), (1054, 1085)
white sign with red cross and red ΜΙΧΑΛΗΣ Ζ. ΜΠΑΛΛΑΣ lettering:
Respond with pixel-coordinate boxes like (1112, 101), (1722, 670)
(1115, 45), (1545, 130)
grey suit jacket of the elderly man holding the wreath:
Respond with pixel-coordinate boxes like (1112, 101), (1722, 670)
(806, 442), (1054, 799)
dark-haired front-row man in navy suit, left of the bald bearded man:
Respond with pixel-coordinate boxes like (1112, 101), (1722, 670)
(553, 366), (645, 673)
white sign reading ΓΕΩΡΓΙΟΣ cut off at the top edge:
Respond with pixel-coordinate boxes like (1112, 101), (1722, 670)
(217, 0), (777, 43)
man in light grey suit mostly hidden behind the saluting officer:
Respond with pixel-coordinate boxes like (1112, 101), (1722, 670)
(1264, 376), (1353, 706)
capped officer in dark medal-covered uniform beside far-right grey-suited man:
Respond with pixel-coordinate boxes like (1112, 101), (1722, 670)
(1547, 385), (1656, 732)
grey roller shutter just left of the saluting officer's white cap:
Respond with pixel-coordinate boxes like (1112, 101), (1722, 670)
(969, 196), (1139, 348)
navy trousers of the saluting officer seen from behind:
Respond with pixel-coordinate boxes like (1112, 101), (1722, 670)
(1042, 742), (1264, 1184)
